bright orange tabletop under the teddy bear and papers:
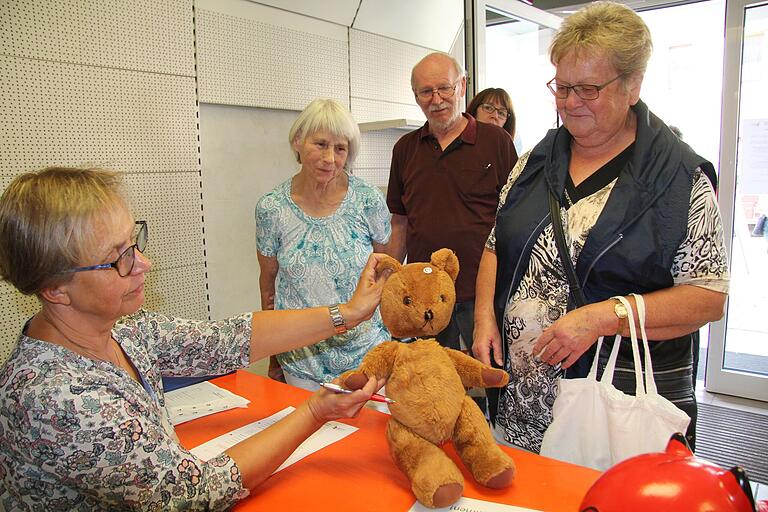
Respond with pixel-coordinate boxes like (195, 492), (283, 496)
(176, 371), (600, 512)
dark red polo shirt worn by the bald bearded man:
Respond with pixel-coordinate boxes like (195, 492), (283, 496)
(387, 114), (517, 302)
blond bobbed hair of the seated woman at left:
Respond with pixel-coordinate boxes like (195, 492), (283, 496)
(0, 167), (127, 295)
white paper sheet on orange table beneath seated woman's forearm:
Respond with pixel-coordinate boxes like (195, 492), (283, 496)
(190, 407), (357, 473)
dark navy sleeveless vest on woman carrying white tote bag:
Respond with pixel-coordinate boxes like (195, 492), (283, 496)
(495, 101), (714, 378)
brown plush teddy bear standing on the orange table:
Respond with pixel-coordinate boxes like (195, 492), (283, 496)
(341, 249), (515, 508)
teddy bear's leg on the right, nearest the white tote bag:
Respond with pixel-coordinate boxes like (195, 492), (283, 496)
(453, 396), (515, 489)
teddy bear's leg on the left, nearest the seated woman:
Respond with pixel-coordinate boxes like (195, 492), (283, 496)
(387, 419), (464, 508)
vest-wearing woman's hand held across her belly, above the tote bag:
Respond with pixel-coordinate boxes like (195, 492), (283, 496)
(532, 302), (618, 368)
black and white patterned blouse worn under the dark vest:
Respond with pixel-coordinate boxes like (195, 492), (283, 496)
(486, 145), (729, 452)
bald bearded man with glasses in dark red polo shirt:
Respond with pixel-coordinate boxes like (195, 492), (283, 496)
(387, 52), (517, 349)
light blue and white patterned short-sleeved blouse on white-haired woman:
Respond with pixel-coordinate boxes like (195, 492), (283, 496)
(256, 176), (392, 382)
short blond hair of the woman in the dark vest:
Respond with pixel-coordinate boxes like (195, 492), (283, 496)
(549, 1), (653, 76)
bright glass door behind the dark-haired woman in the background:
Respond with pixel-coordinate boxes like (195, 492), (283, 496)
(467, 0), (562, 154)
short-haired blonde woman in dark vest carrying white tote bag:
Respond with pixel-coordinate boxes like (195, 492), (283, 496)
(474, 2), (728, 451)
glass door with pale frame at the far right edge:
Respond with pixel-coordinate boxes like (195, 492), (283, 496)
(705, 0), (768, 401)
